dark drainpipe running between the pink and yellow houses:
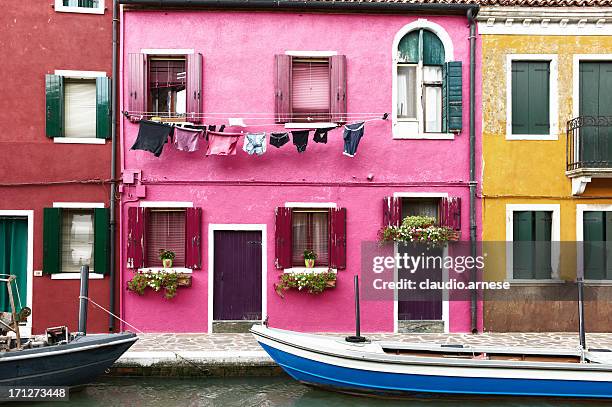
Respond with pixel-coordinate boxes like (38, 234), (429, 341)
(467, 8), (478, 334)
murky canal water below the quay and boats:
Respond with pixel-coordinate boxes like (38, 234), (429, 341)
(35, 377), (606, 407)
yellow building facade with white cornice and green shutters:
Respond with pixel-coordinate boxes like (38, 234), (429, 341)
(478, 7), (612, 332)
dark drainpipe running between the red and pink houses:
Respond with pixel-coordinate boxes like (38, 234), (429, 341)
(108, 0), (119, 332)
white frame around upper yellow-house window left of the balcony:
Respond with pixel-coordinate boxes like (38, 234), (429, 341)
(506, 54), (559, 141)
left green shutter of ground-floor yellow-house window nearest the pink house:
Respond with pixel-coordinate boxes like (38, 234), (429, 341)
(512, 211), (535, 279)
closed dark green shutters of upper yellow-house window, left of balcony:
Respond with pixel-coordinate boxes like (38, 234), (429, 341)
(512, 61), (550, 135)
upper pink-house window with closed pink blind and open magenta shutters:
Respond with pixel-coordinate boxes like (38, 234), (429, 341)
(275, 52), (346, 123)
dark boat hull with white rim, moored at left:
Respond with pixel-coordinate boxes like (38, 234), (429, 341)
(0, 332), (138, 387)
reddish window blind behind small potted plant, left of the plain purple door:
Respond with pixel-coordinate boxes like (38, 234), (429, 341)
(145, 209), (185, 267)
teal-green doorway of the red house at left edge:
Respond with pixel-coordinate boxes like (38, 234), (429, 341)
(0, 217), (28, 312)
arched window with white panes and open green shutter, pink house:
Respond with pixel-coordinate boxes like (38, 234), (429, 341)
(394, 28), (463, 138)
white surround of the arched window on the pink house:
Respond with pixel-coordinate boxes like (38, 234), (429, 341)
(391, 18), (455, 140)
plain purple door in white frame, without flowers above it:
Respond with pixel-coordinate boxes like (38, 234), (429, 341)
(213, 230), (261, 321)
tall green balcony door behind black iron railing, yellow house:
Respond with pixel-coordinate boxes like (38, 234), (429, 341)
(580, 62), (612, 168)
